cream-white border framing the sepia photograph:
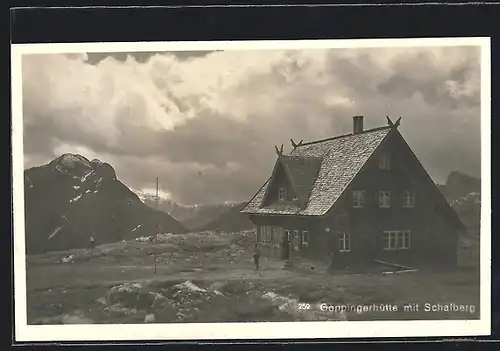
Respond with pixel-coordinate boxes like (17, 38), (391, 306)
(11, 37), (491, 342)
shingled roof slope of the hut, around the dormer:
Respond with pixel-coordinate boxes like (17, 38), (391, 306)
(241, 126), (391, 216)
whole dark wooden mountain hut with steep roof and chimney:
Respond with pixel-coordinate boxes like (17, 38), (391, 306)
(242, 116), (465, 267)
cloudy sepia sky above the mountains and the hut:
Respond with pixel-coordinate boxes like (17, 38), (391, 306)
(22, 47), (480, 208)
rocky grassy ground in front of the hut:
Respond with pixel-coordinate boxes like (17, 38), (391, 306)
(27, 231), (479, 324)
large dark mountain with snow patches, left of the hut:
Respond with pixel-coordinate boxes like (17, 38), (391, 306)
(24, 153), (187, 254)
